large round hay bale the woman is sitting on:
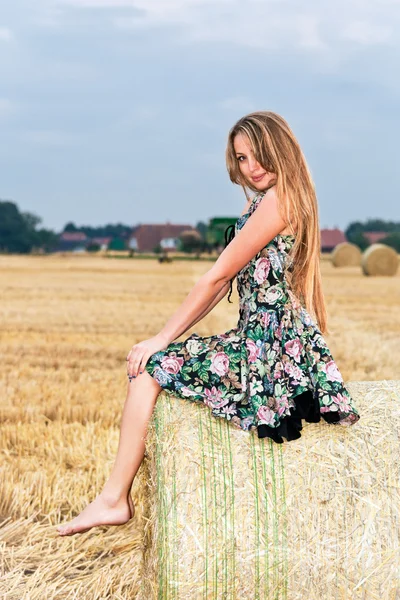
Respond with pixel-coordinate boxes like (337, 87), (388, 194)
(139, 381), (400, 600)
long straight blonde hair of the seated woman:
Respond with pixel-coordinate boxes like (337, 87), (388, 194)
(226, 111), (330, 333)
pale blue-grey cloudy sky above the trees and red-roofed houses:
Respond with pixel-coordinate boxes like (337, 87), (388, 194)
(0, 0), (400, 230)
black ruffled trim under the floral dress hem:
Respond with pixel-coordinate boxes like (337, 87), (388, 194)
(257, 390), (340, 444)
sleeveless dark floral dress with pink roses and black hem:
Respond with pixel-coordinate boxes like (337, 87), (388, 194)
(138, 192), (360, 443)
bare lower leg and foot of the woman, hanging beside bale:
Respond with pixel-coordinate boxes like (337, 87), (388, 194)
(57, 370), (161, 535)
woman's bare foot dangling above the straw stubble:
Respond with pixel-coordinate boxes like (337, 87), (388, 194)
(57, 493), (135, 535)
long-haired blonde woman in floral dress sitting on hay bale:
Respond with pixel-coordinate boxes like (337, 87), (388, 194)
(58, 111), (360, 535)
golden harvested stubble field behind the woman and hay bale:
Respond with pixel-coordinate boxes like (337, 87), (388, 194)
(0, 256), (400, 600)
